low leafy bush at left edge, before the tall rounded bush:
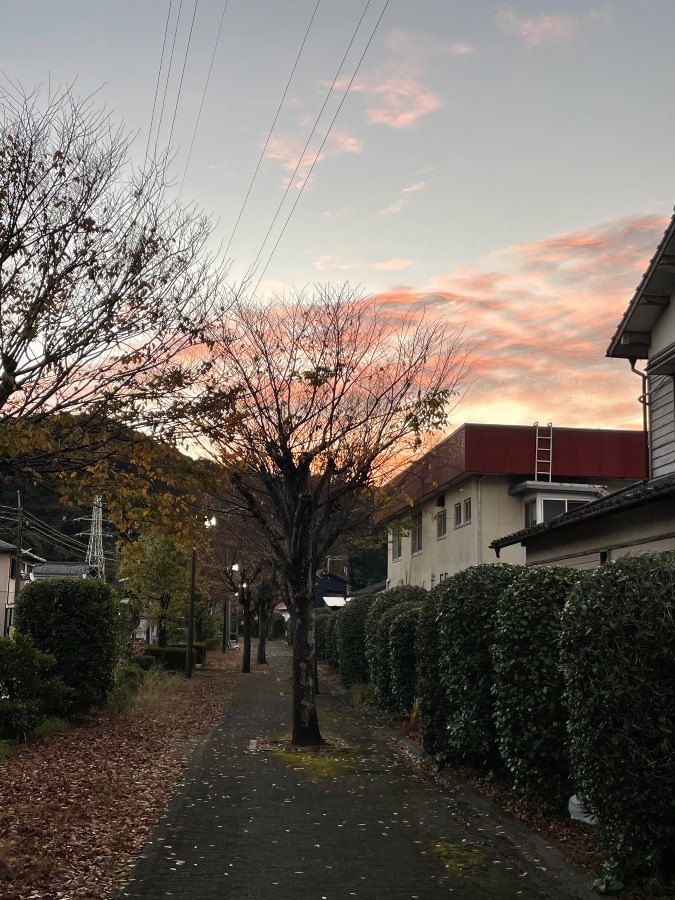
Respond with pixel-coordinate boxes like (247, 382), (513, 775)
(0, 633), (75, 740)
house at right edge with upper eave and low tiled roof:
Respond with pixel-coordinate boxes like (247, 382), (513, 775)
(493, 207), (675, 569)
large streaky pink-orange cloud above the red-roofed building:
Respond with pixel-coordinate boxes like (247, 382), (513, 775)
(374, 216), (669, 427)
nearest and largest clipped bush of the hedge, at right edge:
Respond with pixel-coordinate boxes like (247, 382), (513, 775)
(562, 553), (675, 886)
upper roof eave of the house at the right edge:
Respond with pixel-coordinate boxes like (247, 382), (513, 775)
(606, 215), (675, 360)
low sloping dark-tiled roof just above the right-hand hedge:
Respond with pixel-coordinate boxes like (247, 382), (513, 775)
(490, 474), (675, 556)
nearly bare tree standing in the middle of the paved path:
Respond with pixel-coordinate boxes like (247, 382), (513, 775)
(199, 287), (468, 745)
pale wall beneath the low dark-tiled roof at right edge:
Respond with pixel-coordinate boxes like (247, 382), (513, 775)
(527, 499), (675, 569)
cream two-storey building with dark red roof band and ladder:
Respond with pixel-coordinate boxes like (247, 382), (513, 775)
(382, 424), (645, 588)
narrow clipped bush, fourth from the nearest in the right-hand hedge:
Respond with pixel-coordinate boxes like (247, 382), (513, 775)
(415, 582), (449, 762)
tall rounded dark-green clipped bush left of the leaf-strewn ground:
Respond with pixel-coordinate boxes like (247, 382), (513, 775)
(15, 578), (121, 710)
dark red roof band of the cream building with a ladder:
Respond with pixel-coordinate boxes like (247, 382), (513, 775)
(380, 423), (645, 521)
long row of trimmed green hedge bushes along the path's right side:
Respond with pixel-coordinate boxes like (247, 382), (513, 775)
(325, 553), (675, 892)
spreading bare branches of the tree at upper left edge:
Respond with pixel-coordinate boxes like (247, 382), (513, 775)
(0, 84), (225, 476)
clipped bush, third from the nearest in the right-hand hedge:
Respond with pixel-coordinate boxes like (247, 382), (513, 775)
(435, 563), (524, 766)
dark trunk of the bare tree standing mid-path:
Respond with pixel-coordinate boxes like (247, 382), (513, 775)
(292, 595), (324, 747)
